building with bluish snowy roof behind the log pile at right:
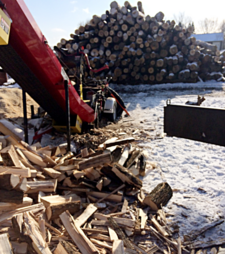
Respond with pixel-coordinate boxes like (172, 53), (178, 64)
(192, 33), (224, 50)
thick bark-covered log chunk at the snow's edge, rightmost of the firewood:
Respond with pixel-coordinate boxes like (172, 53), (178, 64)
(143, 182), (173, 211)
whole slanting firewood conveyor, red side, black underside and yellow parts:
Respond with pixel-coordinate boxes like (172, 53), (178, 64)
(0, 0), (124, 135)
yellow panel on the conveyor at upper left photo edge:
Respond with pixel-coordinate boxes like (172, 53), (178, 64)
(0, 9), (11, 45)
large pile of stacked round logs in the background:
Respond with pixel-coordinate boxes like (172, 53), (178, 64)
(57, 1), (225, 84)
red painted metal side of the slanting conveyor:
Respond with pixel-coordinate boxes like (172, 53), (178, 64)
(1, 0), (95, 122)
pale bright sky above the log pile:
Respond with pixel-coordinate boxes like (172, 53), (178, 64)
(24, 0), (225, 46)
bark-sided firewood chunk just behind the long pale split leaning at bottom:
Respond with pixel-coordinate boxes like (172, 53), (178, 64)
(46, 201), (80, 220)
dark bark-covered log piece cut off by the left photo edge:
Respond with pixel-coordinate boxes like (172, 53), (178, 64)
(0, 190), (24, 204)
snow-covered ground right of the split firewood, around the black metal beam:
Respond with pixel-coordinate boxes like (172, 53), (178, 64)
(114, 81), (225, 242)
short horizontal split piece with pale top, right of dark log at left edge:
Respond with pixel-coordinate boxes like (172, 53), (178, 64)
(26, 179), (57, 193)
